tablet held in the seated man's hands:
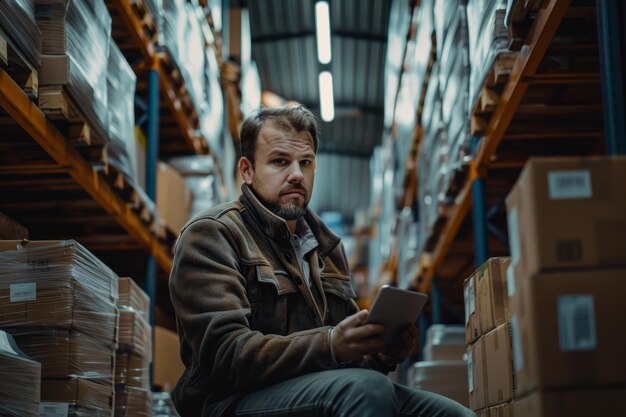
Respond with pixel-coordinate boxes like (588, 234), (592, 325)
(366, 285), (428, 343)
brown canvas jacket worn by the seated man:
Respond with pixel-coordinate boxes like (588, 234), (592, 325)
(169, 184), (358, 417)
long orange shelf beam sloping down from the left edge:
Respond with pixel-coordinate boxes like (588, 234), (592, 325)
(0, 69), (172, 272)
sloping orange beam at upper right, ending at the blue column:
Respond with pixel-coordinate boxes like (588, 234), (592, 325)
(476, 0), (571, 169)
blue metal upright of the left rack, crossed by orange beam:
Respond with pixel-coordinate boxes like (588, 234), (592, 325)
(144, 64), (159, 325)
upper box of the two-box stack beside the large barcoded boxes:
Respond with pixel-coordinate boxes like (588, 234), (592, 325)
(463, 257), (511, 344)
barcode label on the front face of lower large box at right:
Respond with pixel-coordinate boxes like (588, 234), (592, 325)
(558, 294), (597, 352)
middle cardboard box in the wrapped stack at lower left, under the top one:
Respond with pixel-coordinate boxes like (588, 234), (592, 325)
(13, 329), (115, 381)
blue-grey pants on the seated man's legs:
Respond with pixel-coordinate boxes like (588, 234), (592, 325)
(235, 369), (475, 417)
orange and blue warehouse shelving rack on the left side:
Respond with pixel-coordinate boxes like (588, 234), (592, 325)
(0, 0), (229, 325)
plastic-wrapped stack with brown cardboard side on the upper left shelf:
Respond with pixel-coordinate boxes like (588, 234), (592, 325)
(35, 0), (111, 142)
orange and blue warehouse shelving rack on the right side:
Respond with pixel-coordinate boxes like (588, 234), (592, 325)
(392, 0), (626, 322)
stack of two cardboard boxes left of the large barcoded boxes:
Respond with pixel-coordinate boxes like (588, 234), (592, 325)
(464, 258), (515, 415)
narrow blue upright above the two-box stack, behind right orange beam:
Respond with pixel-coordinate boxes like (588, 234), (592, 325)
(472, 136), (489, 266)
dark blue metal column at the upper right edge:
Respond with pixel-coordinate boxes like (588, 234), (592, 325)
(596, 0), (626, 155)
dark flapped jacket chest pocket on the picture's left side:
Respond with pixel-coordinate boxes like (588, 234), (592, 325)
(247, 265), (296, 335)
